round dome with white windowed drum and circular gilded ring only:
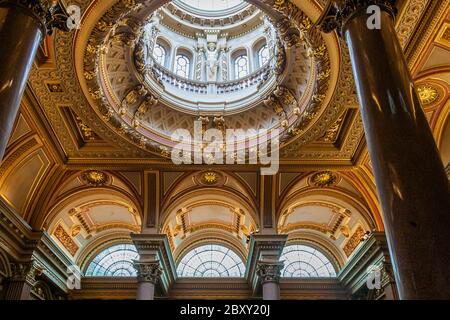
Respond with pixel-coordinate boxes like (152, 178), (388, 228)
(84, 0), (331, 157)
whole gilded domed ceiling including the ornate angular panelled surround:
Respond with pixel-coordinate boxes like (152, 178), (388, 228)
(24, 0), (396, 164)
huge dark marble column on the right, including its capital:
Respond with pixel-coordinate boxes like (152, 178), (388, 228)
(321, 0), (450, 299)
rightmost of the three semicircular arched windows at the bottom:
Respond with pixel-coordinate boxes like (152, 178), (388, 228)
(280, 245), (336, 278)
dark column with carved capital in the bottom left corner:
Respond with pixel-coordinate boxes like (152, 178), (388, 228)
(5, 261), (42, 300)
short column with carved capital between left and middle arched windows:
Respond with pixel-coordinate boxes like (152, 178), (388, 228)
(134, 261), (162, 300)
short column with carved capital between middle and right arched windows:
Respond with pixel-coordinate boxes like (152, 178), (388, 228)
(256, 261), (283, 300)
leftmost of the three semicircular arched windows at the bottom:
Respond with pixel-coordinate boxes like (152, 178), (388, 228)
(86, 244), (139, 277)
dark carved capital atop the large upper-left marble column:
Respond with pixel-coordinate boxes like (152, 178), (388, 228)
(0, 0), (69, 34)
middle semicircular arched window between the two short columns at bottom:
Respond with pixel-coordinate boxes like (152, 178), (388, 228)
(177, 245), (245, 278)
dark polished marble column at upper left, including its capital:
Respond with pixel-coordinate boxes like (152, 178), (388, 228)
(0, 0), (64, 160)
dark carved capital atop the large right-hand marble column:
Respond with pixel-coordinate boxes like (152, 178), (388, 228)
(318, 0), (397, 35)
